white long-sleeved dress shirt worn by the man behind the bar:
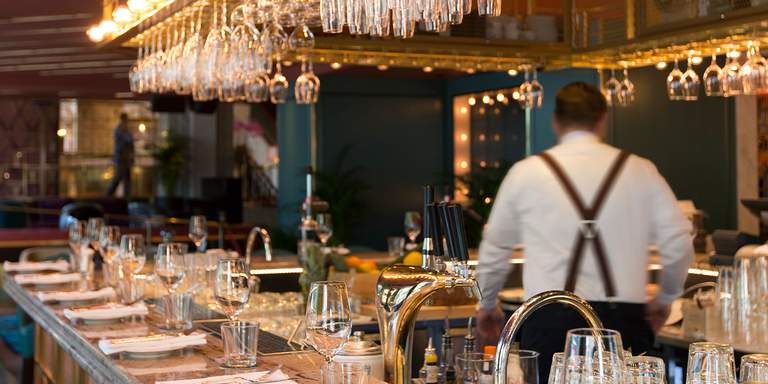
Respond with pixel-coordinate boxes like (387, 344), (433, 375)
(477, 131), (693, 308)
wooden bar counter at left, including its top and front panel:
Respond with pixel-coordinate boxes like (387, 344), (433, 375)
(3, 273), (322, 384)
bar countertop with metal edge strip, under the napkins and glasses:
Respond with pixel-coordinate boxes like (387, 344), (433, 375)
(3, 273), (324, 384)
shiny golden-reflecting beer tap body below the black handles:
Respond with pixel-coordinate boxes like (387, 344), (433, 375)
(376, 265), (480, 384)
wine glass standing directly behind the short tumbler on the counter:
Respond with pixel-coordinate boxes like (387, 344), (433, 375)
(213, 257), (251, 322)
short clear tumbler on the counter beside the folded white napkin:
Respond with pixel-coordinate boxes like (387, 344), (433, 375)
(221, 321), (259, 368)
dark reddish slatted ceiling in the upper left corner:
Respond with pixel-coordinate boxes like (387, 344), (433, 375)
(0, 0), (135, 98)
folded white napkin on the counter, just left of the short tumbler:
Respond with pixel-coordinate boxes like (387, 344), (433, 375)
(99, 332), (206, 355)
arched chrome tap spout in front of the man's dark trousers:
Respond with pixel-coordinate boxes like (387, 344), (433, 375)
(493, 291), (603, 384)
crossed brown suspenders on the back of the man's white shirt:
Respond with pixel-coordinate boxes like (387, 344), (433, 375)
(539, 151), (629, 297)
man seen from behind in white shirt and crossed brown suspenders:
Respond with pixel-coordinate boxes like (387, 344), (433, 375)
(477, 82), (693, 382)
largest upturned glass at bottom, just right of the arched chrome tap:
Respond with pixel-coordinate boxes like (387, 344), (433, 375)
(563, 328), (624, 384)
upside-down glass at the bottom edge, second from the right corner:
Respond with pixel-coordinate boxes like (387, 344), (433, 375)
(685, 342), (736, 384)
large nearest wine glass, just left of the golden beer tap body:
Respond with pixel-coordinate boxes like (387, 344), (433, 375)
(305, 281), (352, 380)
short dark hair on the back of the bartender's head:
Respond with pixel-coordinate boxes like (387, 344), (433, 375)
(555, 81), (608, 128)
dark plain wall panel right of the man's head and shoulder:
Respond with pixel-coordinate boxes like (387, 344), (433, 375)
(609, 61), (736, 229)
